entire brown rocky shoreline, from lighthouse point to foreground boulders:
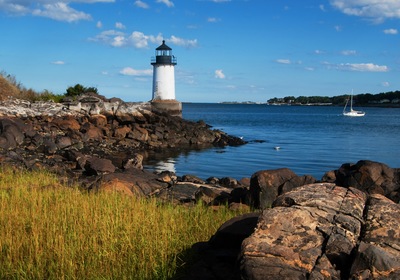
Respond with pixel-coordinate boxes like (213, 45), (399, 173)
(0, 95), (400, 279)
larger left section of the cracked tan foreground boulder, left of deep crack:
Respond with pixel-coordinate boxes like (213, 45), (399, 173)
(242, 183), (367, 279)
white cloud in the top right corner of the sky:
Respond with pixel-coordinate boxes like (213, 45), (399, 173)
(330, 0), (400, 22)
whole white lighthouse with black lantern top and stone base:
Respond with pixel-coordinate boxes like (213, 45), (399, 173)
(151, 40), (182, 116)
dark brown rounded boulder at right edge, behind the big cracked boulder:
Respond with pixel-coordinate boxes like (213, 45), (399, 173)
(336, 160), (400, 203)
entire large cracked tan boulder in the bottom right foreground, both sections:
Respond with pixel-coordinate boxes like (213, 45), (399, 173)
(241, 183), (400, 280)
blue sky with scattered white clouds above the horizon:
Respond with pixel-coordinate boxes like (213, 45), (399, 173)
(0, 0), (400, 102)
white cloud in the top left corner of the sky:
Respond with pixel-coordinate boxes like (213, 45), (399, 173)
(0, 0), (115, 22)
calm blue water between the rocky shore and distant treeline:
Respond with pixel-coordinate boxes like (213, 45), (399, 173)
(145, 103), (400, 179)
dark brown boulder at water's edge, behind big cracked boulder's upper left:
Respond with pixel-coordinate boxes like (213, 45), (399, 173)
(250, 168), (316, 209)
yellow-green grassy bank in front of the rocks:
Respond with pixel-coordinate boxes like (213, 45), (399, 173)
(0, 168), (247, 279)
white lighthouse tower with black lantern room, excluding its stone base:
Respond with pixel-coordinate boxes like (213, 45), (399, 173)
(151, 40), (176, 101)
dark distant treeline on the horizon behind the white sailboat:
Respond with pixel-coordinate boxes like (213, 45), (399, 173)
(267, 90), (400, 105)
